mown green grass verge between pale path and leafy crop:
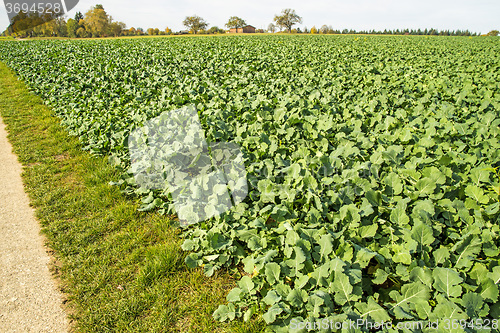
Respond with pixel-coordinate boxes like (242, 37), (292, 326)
(0, 63), (263, 332)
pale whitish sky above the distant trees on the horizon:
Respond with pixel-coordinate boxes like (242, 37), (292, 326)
(0, 0), (500, 34)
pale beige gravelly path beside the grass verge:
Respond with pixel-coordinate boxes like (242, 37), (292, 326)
(0, 118), (68, 333)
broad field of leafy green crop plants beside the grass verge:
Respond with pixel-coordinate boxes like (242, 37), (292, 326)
(0, 35), (500, 332)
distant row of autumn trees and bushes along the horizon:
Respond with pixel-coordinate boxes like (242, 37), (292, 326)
(2, 5), (498, 38)
